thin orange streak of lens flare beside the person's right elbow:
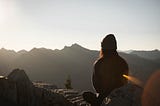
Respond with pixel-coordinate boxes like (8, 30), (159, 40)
(123, 74), (144, 87)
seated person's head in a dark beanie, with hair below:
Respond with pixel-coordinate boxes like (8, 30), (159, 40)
(100, 34), (117, 57)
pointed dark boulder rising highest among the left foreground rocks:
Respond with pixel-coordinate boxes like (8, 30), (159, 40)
(8, 69), (35, 106)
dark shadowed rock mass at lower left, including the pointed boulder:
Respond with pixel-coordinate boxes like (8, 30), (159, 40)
(0, 69), (73, 106)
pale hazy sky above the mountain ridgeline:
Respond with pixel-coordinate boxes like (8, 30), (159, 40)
(0, 0), (160, 51)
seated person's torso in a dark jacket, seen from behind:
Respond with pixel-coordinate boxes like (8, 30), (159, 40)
(93, 51), (128, 96)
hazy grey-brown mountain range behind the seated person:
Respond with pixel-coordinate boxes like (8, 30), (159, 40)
(0, 44), (160, 90)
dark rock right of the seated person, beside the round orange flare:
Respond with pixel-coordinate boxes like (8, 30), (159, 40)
(102, 83), (143, 106)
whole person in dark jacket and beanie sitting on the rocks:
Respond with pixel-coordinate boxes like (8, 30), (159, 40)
(83, 34), (129, 106)
